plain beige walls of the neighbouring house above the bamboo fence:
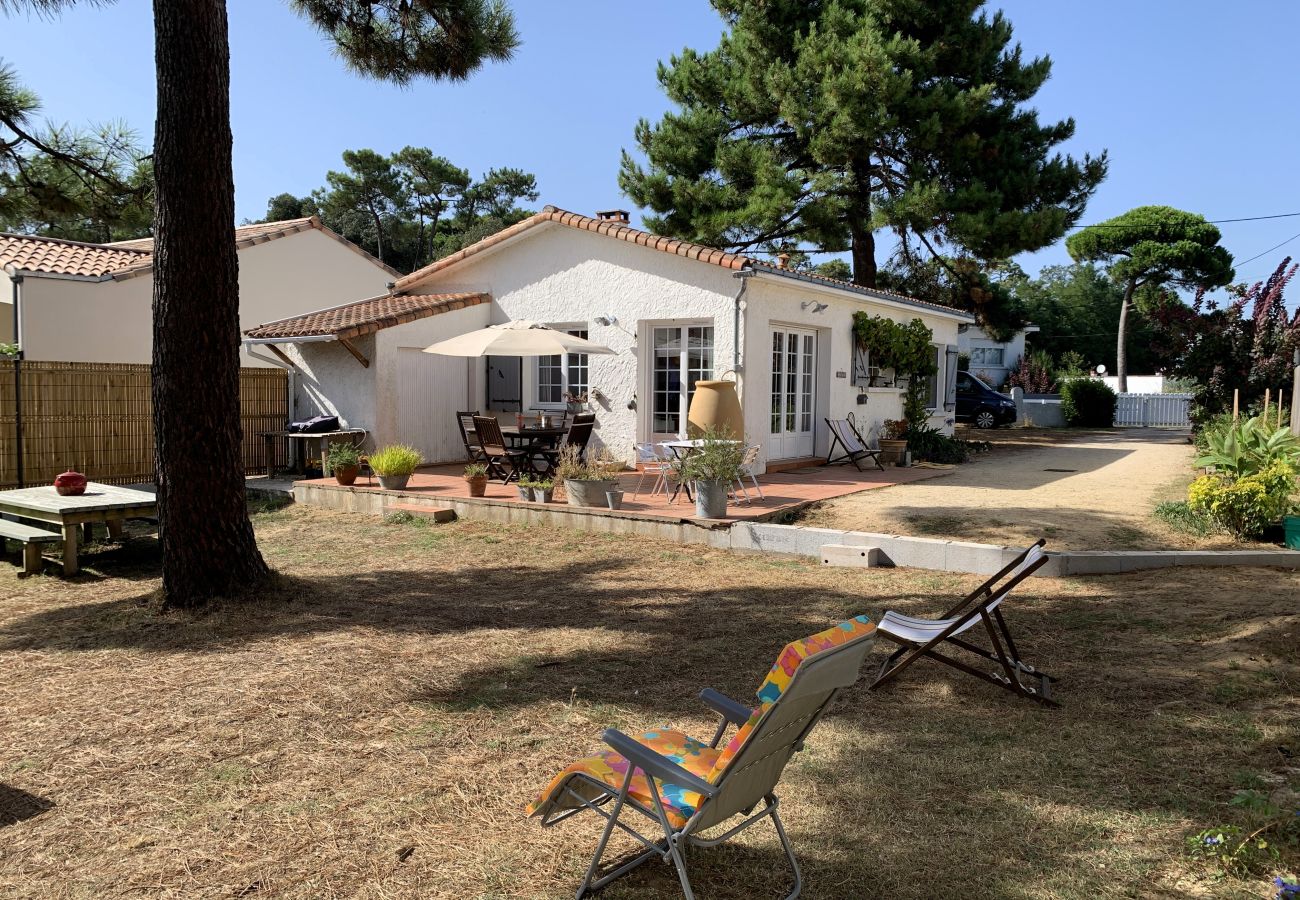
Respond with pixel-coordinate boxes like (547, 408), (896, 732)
(10, 229), (394, 365)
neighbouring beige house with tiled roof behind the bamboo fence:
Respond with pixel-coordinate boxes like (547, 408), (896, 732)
(0, 217), (399, 365)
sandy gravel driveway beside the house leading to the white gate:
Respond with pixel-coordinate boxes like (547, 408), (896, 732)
(805, 428), (1216, 550)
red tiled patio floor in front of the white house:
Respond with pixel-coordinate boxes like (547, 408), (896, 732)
(299, 464), (952, 520)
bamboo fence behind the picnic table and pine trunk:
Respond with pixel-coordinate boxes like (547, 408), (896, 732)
(0, 360), (289, 488)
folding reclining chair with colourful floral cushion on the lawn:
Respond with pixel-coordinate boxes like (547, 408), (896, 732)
(528, 615), (875, 900)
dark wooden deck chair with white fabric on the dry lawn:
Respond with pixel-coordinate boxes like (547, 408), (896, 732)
(867, 538), (1060, 706)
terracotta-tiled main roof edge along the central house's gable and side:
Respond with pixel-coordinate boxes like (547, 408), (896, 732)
(393, 207), (974, 321)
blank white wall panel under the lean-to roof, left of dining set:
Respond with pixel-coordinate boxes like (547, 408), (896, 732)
(398, 347), (473, 463)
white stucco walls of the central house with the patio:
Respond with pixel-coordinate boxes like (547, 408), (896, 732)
(412, 225), (957, 463)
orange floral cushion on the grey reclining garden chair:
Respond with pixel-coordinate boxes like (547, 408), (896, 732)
(528, 615), (875, 828)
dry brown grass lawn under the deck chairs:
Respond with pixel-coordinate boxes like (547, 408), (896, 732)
(0, 509), (1300, 899)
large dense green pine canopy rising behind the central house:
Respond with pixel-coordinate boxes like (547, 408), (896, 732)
(619, 0), (1106, 319)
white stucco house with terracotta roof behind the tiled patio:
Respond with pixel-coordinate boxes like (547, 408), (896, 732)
(246, 207), (974, 466)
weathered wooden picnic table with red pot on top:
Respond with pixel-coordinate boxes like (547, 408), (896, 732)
(0, 481), (159, 575)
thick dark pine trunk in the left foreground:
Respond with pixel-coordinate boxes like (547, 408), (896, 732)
(153, 0), (268, 606)
